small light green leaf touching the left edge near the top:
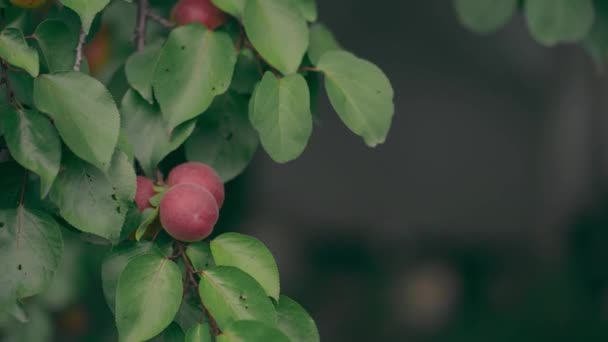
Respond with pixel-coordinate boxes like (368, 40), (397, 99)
(0, 27), (40, 77)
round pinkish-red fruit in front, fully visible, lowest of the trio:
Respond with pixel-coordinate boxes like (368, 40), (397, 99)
(160, 184), (219, 242)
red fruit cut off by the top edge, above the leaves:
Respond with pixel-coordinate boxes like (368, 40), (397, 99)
(171, 0), (228, 30)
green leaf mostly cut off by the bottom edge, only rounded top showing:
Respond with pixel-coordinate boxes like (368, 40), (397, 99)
(216, 320), (296, 342)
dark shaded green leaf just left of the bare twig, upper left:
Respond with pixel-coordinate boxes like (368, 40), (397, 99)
(33, 19), (78, 72)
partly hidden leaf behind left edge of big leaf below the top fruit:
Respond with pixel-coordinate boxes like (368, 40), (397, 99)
(125, 44), (162, 104)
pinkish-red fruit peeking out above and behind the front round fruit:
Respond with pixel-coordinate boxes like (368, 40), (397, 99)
(167, 162), (224, 208)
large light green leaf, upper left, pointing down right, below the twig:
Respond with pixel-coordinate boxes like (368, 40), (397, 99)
(34, 71), (120, 170)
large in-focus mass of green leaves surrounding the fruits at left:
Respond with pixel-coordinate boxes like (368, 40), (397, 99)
(0, 0), (394, 341)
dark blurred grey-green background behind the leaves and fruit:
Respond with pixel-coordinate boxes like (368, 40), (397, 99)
(9, 0), (608, 342)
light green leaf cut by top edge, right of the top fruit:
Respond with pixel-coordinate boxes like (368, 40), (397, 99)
(243, 0), (308, 75)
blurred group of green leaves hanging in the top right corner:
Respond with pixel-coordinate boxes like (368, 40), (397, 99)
(454, 0), (608, 65)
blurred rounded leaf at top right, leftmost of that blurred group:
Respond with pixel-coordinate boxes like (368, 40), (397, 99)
(454, 0), (517, 33)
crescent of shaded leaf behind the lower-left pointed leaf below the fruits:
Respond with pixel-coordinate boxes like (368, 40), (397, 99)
(101, 241), (160, 312)
